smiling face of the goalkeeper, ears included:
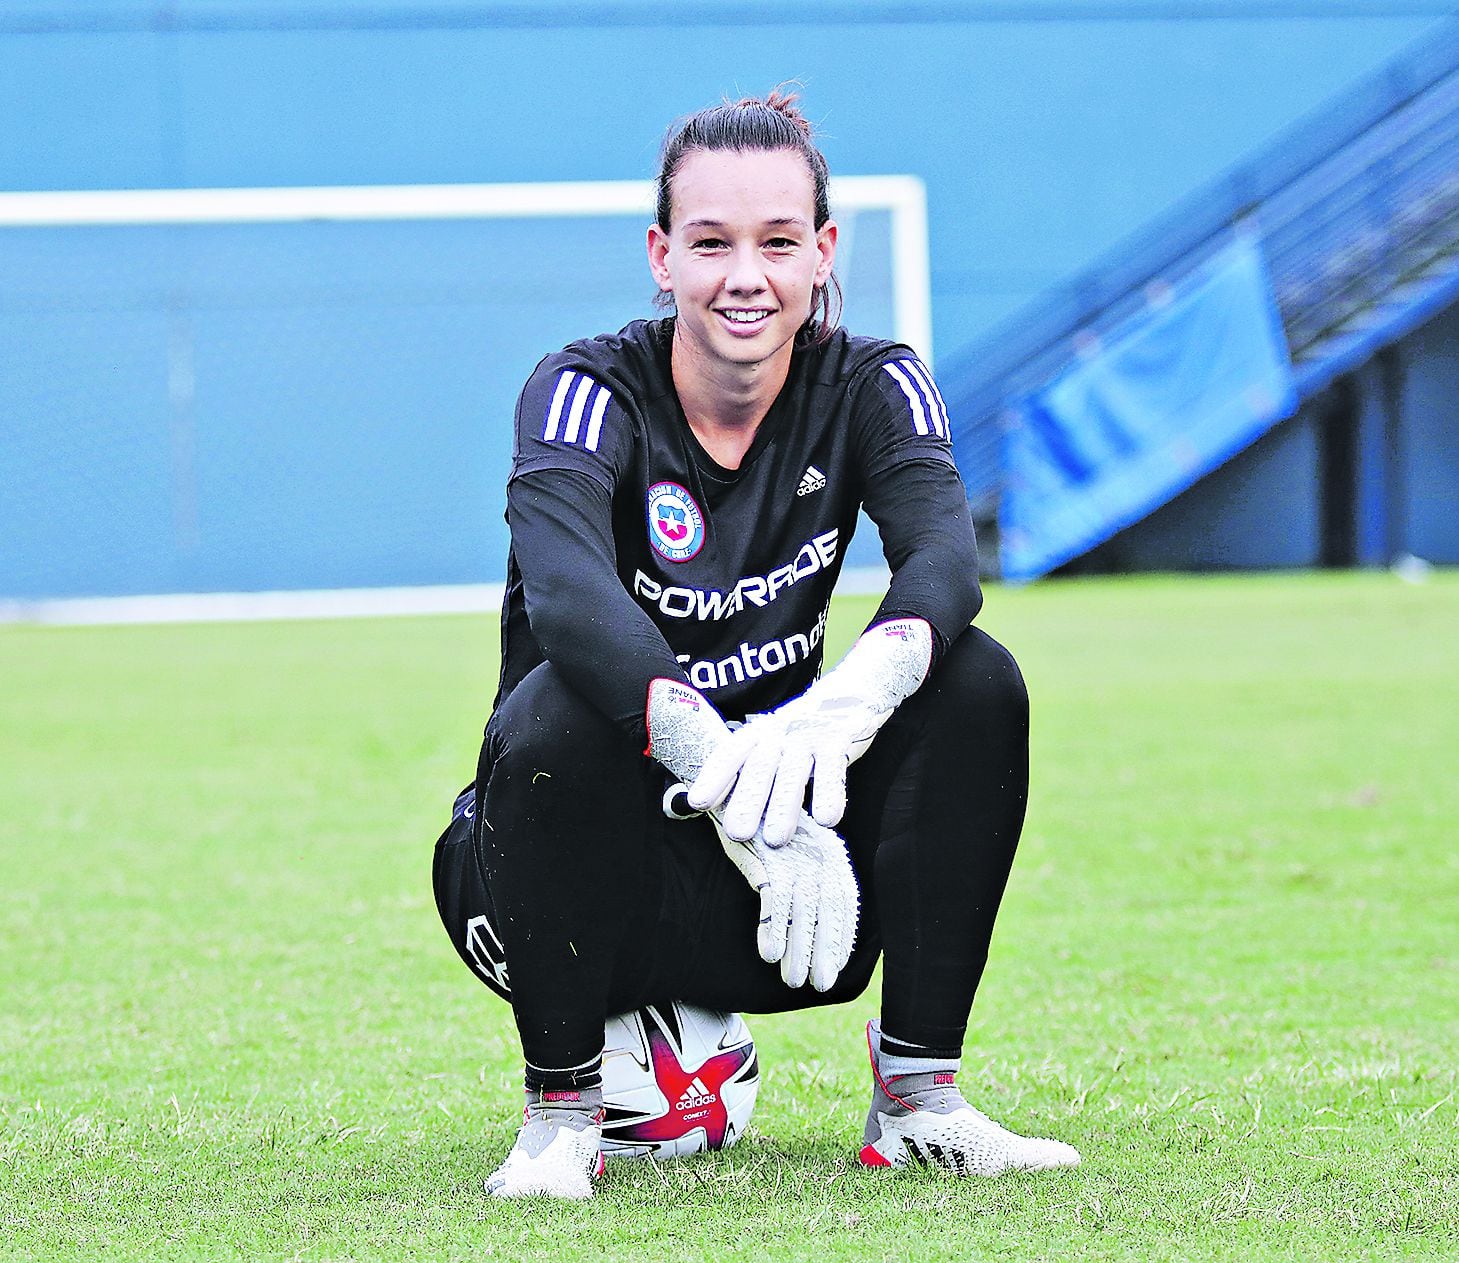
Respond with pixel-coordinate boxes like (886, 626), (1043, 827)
(648, 149), (836, 368)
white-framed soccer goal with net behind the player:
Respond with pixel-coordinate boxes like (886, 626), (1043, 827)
(0, 175), (932, 617)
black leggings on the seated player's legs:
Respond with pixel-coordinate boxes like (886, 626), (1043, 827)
(435, 627), (1029, 1069)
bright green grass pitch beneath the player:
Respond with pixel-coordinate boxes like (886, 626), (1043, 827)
(0, 573), (1459, 1260)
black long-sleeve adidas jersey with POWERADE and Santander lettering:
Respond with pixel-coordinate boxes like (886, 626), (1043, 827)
(498, 319), (982, 739)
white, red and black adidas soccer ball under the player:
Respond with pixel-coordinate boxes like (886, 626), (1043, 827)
(603, 1000), (760, 1158)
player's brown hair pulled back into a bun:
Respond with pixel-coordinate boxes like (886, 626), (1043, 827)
(655, 88), (840, 343)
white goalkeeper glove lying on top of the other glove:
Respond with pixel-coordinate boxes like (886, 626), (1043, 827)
(676, 618), (932, 847)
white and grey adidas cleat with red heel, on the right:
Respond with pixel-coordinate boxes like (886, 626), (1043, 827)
(861, 1020), (1080, 1175)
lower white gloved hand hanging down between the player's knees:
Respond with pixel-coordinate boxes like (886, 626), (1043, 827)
(709, 811), (861, 992)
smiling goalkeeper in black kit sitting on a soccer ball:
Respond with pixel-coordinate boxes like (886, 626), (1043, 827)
(435, 93), (1078, 1197)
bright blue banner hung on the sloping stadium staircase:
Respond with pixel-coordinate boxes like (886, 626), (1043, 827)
(999, 238), (1297, 582)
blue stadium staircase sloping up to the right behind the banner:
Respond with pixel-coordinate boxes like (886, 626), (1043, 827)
(938, 22), (1459, 578)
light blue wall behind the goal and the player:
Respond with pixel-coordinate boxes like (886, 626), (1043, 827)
(0, 0), (1449, 596)
